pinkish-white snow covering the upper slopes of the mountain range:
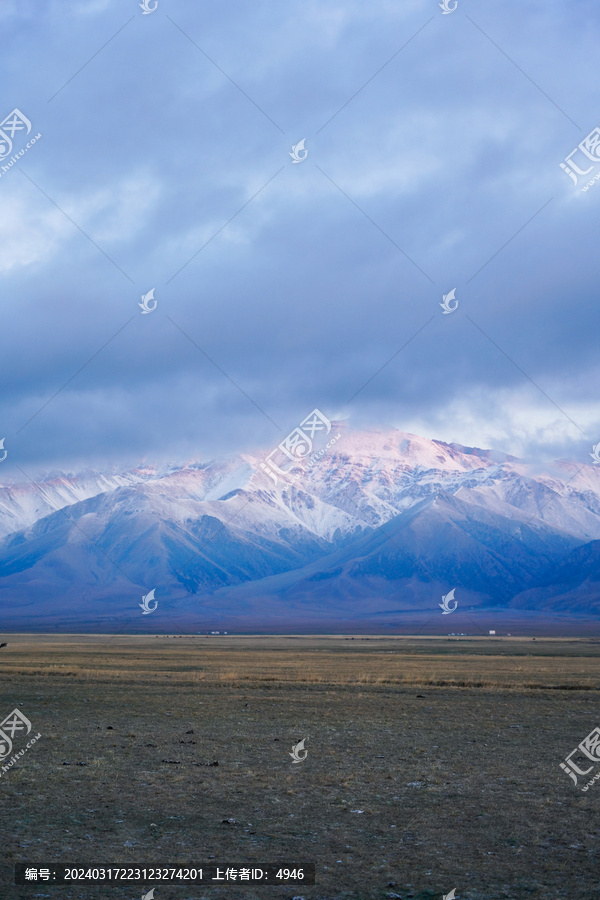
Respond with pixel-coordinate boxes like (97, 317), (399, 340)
(0, 429), (600, 540)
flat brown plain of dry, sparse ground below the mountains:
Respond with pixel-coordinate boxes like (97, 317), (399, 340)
(0, 635), (600, 900)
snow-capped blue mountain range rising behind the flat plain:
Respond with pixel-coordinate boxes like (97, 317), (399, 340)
(0, 429), (600, 630)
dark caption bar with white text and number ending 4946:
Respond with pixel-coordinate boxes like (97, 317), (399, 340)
(15, 863), (315, 885)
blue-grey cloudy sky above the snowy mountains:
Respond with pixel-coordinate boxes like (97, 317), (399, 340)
(0, 0), (600, 477)
